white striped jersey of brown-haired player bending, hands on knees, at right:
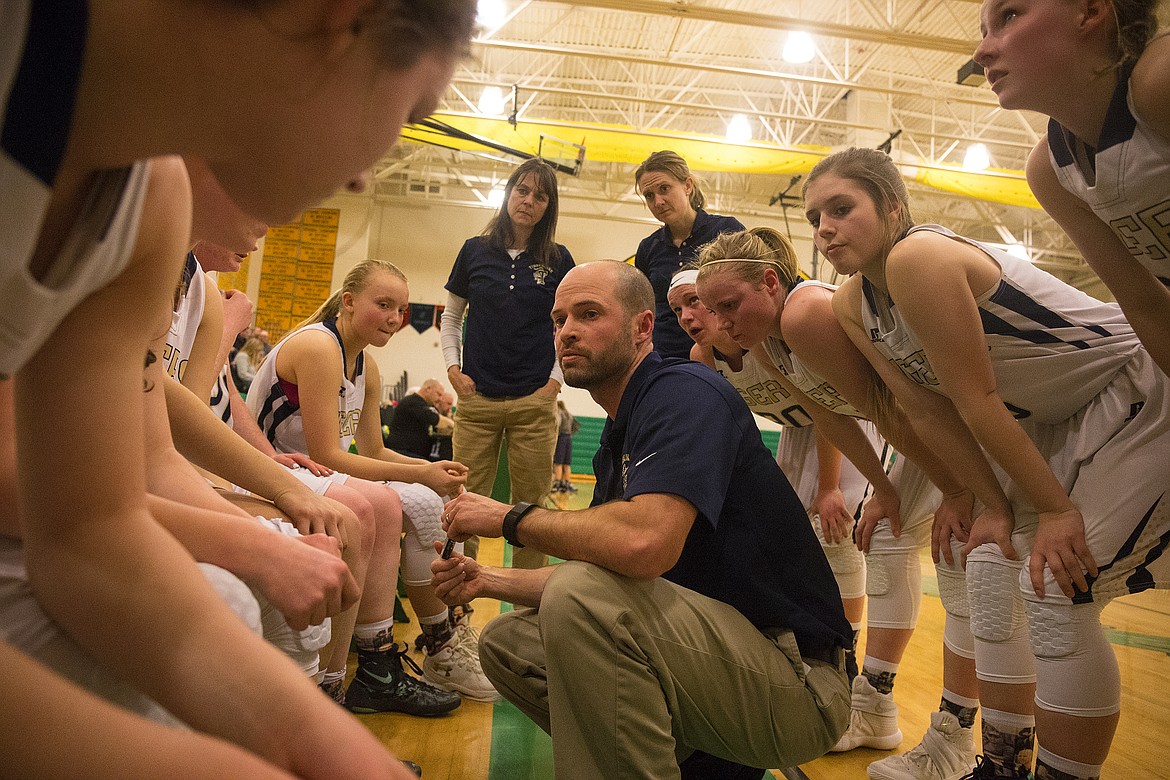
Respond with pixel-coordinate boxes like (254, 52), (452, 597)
(861, 225), (1140, 423)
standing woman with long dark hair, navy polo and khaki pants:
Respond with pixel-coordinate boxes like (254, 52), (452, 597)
(441, 159), (573, 568)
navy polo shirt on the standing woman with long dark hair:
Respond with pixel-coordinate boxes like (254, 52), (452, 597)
(447, 236), (573, 398)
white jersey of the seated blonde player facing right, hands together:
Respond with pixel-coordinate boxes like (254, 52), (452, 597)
(247, 319), (365, 455)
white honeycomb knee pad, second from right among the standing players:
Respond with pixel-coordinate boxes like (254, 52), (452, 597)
(966, 544), (1035, 685)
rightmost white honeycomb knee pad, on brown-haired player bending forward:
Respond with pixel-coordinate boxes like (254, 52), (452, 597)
(1024, 594), (1121, 718)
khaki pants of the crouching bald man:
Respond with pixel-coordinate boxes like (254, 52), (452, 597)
(480, 561), (849, 780)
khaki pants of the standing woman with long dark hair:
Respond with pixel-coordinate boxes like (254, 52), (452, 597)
(452, 393), (559, 568)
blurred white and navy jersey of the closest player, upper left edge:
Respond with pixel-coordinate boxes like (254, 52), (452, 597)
(0, 2), (150, 378)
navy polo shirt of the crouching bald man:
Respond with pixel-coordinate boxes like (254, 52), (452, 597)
(593, 353), (852, 650)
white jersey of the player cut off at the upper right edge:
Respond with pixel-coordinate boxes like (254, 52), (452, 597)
(1048, 57), (1170, 285)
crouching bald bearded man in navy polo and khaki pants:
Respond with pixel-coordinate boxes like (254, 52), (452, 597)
(432, 262), (849, 780)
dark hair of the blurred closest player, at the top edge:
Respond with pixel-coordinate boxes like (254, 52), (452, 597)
(360, 0), (476, 70)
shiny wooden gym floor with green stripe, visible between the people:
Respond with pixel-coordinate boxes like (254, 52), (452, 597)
(350, 483), (1170, 780)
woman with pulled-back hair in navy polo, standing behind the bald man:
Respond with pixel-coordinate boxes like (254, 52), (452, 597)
(634, 150), (744, 358)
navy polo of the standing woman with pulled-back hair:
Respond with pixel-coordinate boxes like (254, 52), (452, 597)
(634, 208), (744, 358)
